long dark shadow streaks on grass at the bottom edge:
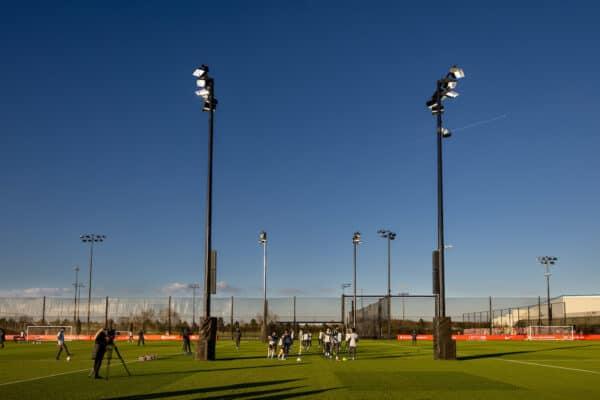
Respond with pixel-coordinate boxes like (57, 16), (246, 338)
(106, 379), (302, 400)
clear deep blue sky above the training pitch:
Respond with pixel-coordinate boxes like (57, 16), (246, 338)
(0, 1), (600, 296)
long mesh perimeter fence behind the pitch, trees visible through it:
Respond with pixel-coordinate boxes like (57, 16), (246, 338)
(0, 295), (600, 338)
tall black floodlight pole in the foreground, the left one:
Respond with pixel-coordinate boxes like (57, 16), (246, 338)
(192, 64), (218, 361)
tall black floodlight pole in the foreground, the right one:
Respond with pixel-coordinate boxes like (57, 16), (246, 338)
(426, 65), (465, 359)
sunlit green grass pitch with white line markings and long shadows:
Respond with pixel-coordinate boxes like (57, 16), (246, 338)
(0, 340), (600, 400)
